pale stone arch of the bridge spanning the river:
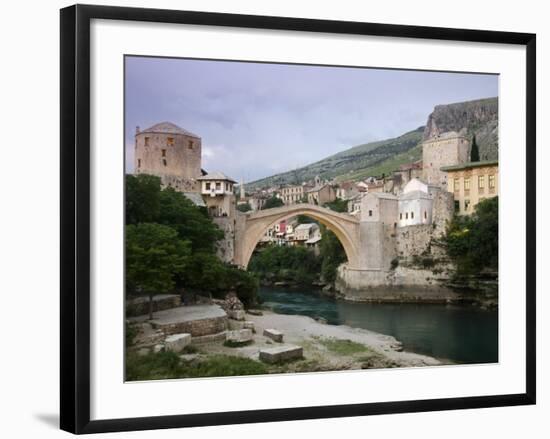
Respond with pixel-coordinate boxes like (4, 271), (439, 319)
(235, 204), (360, 268)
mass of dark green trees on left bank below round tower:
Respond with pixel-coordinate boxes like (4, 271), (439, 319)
(126, 174), (258, 304)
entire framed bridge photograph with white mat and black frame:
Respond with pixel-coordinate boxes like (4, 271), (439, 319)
(61, 5), (536, 433)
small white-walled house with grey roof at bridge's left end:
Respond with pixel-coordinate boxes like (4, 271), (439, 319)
(197, 172), (236, 217)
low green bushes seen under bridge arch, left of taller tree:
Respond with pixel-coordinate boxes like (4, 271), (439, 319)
(248, 245), (320, 285)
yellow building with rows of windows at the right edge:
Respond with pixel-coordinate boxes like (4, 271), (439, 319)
(441, 161), (498, 215)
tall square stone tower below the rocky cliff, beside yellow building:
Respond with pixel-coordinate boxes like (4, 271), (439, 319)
(422, 131), (470, 189)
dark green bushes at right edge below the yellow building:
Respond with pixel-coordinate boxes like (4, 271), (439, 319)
(444, 197), (498, 274)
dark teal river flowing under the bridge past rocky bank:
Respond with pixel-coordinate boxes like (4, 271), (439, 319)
(259, 288), (498, 364)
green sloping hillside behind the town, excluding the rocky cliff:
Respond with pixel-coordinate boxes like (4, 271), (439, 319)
(247, 127), (424, 190)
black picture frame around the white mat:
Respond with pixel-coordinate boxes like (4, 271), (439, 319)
(60, 5), (536, 434)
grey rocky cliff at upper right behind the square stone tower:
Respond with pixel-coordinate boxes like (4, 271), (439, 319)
(424, 98), (498, 160)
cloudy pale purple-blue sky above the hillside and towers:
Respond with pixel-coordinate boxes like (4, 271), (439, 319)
(125, 57), (498, 181)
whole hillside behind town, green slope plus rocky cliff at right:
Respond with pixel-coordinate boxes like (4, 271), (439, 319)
(247, 98), (498, 190)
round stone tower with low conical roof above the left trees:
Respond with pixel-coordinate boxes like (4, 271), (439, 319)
(134, 122), (202, 192)
